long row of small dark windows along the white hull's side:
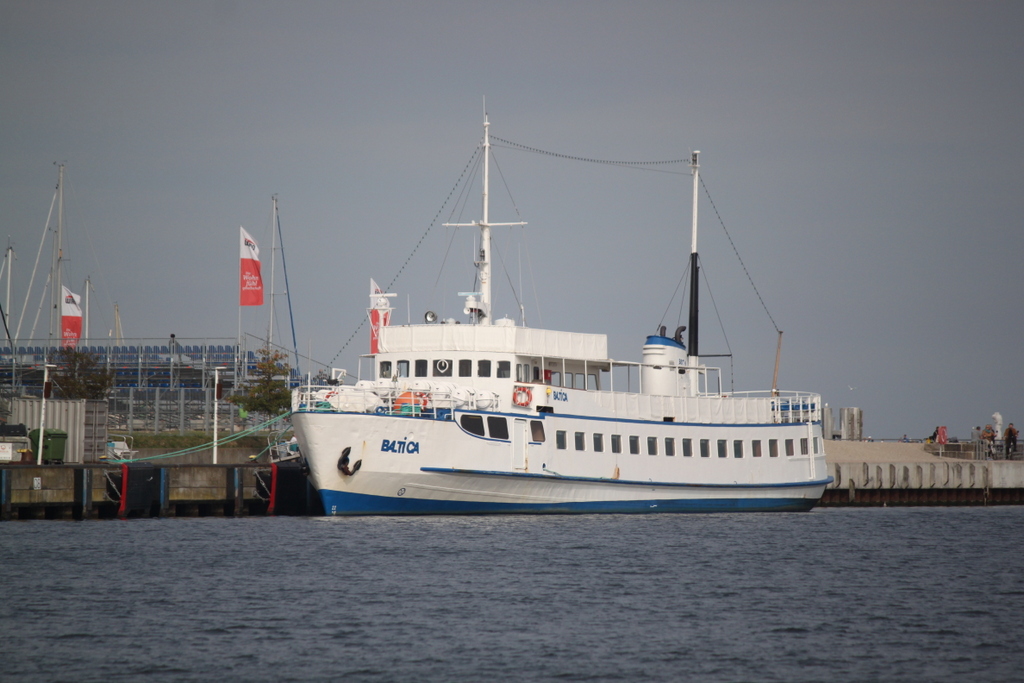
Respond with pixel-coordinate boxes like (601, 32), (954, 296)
(555, 429), (820, 458)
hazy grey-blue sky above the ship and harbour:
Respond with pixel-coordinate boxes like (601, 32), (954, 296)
(0, 0), (1024, 438)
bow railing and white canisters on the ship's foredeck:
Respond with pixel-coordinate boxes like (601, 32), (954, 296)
(292, 381), (500, 420)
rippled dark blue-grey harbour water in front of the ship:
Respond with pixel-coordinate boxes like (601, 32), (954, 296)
(0, 507), (1024, 681)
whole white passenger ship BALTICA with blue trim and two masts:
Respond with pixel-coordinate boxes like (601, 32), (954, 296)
(292, 119), (831, 515)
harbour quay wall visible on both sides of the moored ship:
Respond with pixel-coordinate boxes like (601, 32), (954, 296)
(0, 441), (1024, 519)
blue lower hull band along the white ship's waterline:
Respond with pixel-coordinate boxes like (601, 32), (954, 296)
(319, 490), (818, 515)
